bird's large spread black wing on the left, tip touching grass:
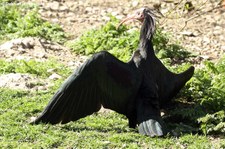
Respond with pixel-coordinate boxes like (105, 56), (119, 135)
(32, 52), (141, 124)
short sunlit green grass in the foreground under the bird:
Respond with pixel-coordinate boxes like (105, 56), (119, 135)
(0, 89), (224, 149)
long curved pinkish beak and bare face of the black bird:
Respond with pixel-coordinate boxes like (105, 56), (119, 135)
(117, 8), (144, 29)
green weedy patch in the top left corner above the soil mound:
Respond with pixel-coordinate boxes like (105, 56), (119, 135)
(0, 0), (66, 43)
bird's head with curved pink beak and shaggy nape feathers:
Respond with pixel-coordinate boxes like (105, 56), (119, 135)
(118, 7), (157, 40)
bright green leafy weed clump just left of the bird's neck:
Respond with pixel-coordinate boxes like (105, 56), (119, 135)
(66, 17), (138, 60)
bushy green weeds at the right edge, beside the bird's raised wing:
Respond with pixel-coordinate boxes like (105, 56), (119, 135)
(167, 56), (225, 134)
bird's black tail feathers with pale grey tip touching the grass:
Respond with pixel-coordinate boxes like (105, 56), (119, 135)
(136, 77), (166, 137)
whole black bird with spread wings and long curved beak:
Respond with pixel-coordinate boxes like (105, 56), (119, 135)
(32, 8), (194, 136)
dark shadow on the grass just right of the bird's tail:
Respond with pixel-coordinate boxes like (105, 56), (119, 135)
(163, 101), (205, 136)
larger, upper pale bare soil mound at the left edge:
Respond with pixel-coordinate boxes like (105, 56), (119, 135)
(0, 37), (86, 67)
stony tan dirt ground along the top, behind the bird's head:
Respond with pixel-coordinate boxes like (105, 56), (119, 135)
(33, 0), (225, 59)
